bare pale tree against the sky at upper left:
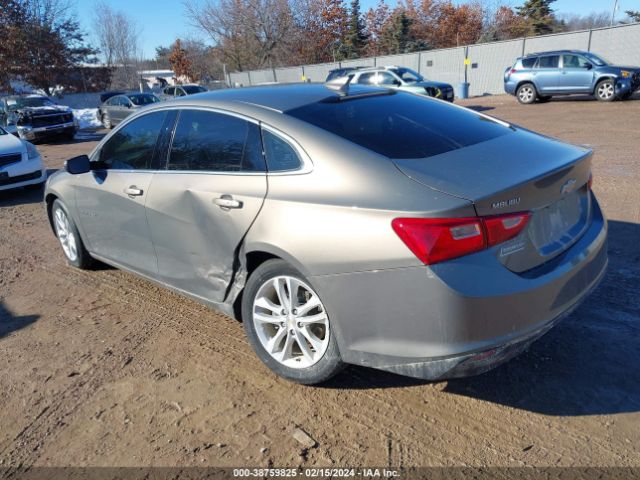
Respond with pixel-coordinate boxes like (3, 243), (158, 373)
(93, 1), (142, 88)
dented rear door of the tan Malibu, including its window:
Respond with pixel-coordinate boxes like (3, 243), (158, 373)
(146, 109), (267, 302)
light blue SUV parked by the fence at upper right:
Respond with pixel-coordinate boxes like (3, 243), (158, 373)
(504, 50), (640, 104)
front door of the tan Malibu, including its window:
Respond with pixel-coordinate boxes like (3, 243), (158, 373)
(75, 111), (171, 276)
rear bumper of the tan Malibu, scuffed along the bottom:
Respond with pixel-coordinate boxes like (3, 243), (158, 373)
(311, 194), (608, 380)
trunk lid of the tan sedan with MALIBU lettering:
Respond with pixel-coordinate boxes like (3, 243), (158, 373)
(393, 129), (592, 272)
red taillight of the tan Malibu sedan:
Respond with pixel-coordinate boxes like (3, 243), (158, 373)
(391, 212), (531, 265)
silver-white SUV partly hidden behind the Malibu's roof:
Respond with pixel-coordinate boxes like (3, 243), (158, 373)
(327, 66), (454, 102)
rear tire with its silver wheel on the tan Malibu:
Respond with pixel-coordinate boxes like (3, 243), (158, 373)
(242, 259), (344, 385)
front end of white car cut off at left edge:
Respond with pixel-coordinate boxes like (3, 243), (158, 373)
(0, 128), (47, 191)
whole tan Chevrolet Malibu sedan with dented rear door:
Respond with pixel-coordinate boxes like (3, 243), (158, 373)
(45, 84), (607, 383)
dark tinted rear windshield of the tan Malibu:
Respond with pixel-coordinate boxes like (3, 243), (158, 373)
(285, 92), (512, 159)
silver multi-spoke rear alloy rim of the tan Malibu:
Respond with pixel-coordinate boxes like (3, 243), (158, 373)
(253, 276), (330, 368)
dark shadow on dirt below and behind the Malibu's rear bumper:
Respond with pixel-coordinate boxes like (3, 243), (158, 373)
(326, 221), (640, 416)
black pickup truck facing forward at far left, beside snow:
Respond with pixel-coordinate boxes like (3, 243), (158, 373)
(0, 95), (79, 141)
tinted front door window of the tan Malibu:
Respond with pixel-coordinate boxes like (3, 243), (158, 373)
(96, 112), (167, 170)
